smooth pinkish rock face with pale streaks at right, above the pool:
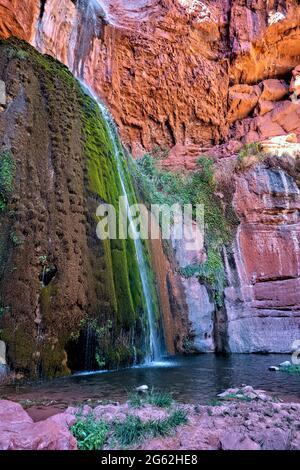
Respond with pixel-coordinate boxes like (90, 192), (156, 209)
(226, 165), (300, 352)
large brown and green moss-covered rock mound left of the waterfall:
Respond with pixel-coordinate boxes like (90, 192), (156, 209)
(0, 39), (145, 376)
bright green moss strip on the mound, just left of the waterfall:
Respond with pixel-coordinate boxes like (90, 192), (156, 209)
(82, 94), (144, 338)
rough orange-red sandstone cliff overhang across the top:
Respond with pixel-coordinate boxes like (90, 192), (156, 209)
(0, 0), (300, 154)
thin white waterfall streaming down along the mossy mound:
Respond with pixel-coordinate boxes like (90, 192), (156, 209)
(33, 0), (164, 363)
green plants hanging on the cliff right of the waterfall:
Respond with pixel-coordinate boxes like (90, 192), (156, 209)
(133, 153), (234, 305)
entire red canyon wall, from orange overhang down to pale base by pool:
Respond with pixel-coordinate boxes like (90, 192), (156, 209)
(0, 0), (300, 358)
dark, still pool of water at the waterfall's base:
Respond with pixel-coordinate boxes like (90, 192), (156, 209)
(0, 354), (300, 404)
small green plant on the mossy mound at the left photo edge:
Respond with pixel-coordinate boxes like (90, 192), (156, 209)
(0, 150), (15, 213)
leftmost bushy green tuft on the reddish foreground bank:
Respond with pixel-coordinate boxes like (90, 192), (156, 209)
(71, 415), (109, 450)
